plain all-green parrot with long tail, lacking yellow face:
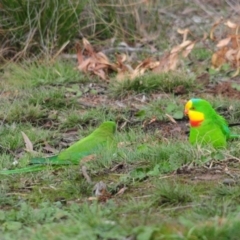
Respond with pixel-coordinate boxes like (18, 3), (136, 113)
(0, 121), (116, 175)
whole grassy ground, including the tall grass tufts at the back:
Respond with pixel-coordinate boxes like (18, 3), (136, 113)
(0, 0), (240, 240)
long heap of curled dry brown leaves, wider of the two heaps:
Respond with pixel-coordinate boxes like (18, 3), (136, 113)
(77, 29), (195, 81)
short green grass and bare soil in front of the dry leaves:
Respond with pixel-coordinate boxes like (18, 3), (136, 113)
(0, 57), (240, 240)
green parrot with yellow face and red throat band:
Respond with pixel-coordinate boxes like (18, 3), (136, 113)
(184, 98), (240, 148)
